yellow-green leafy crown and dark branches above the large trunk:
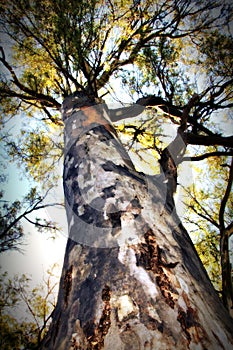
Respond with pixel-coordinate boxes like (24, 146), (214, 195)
(1, 1), (233, 348)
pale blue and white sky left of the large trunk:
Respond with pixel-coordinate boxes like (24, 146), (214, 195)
(0, 116), (67, 284)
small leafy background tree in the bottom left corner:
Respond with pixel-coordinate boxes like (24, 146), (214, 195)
(0, 265), (57, 350)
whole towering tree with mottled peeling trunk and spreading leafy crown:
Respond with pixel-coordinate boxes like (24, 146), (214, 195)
(0, 0), (233, 349)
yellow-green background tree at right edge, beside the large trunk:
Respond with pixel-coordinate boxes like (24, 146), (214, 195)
(183, 156), (232, 305)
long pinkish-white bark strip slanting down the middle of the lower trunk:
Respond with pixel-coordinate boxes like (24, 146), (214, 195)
(118, 246), (159, 299)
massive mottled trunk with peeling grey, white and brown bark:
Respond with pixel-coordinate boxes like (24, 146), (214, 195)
(43, 94), (233, 350)
